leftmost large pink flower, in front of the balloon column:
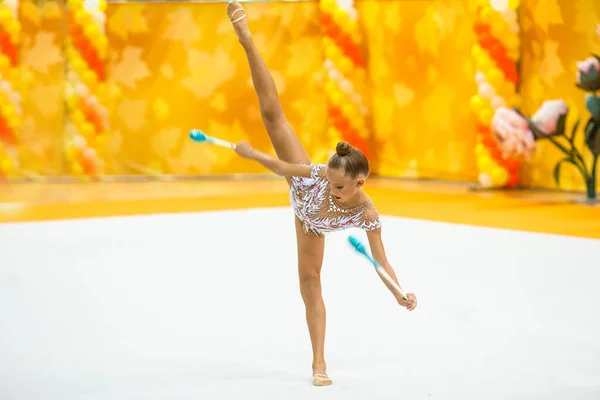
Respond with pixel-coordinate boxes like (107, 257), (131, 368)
(492, 107), (535, 159)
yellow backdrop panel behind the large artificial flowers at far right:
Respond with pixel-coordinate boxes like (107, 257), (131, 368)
(521, 0), (600, 190)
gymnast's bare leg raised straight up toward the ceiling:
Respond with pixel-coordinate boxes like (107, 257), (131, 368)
(227, 1), (310, 164)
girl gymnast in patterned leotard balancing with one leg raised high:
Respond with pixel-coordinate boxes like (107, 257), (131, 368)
(226, 1), (417, 386)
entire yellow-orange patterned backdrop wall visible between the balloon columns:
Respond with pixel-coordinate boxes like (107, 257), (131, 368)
(4, 0), (600, 193)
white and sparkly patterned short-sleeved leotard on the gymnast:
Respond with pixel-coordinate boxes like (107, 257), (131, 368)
(290, 165), (381, 236)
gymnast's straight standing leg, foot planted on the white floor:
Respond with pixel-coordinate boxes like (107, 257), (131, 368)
(296, 217), (331, 386)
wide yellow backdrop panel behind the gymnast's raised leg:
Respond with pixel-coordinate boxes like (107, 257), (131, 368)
(107, 2), (327, 174)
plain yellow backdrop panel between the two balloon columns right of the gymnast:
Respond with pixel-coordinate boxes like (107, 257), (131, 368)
(357, 0), (477, 179)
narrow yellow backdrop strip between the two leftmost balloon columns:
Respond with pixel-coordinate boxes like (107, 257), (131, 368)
(19, 1), (65, 176)
